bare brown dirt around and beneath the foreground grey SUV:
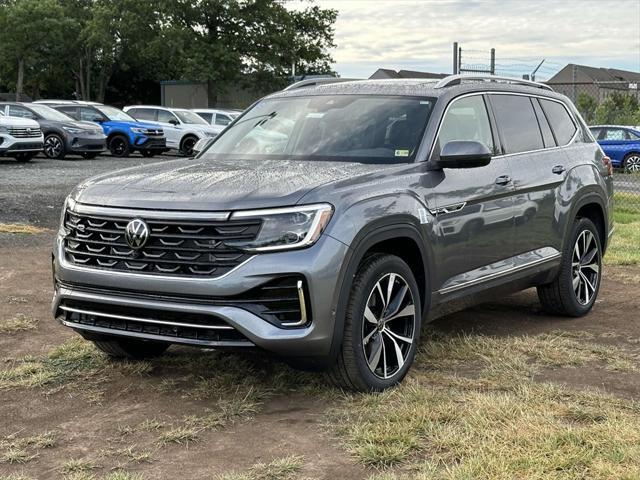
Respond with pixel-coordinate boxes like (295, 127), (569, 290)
(0, 240), (640, 479)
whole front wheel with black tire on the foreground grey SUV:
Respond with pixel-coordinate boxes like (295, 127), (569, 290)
(328, 254), (422, 392)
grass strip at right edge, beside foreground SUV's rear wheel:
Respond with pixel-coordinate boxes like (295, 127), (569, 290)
(605, 192), (640, 265)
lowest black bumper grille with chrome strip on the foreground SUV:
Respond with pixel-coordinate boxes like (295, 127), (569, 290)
(59, 300), (253, 346)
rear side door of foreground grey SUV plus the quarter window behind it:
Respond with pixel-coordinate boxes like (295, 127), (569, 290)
(490, 94), (577, 258)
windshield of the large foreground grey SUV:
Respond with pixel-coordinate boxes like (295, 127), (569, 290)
(203, 95), (435, 163)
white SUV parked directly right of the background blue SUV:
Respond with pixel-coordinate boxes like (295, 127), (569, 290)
(123, 105), (219, 156)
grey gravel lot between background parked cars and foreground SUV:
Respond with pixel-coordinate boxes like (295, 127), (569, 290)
(0, 154), (185, 228)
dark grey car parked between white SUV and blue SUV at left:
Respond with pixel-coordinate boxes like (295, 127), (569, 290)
(0, 102), (106, 160)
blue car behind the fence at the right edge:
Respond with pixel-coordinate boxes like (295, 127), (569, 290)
(589, 125), (640, 173)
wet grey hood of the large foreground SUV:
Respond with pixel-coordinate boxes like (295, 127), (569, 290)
(72, 159), (389, 211)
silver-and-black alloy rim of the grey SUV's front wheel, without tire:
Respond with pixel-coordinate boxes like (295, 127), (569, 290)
(362, 273), (416, 379)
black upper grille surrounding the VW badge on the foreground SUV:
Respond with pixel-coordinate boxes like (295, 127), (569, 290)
(64, 211), (261, 277)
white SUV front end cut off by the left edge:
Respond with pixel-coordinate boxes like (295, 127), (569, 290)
(0, 109), (44, 162)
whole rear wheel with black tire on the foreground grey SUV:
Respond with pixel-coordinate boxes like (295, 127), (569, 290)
(538, 218), (602, 317)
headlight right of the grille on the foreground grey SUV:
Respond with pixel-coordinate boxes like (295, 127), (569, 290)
(226, 203), (333, 252)
